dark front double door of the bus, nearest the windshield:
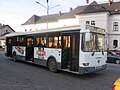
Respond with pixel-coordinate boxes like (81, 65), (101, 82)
(61, 33), (79, 71)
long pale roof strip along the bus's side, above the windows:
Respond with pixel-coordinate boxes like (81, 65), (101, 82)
(6, 25), (80, 37)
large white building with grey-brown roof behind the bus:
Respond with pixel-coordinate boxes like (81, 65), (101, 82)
(22, 0), (120, 50)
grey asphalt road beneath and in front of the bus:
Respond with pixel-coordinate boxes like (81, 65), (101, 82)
(0, 51), (120, 90)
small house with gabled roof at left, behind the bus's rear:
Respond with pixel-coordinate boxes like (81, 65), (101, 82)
(0, 24), (15, 48)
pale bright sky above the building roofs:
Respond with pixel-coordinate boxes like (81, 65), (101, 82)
(0, 0), (120, 31)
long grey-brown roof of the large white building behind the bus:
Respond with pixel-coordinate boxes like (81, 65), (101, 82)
(22, 1), (120, 25)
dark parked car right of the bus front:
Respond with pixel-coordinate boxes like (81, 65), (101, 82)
(107, 51), (120, 64)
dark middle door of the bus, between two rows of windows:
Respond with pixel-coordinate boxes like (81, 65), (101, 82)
(26, 36), (34, 61)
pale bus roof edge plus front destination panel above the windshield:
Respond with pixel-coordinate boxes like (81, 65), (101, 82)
(6, 25), (106, 37)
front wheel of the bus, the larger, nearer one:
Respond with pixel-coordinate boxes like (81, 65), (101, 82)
(48, 58), (57, 72)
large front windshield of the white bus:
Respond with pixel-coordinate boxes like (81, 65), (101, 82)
(82, 32), (106, 52)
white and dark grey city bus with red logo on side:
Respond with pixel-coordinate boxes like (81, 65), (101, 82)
(5, 25), (107, 74)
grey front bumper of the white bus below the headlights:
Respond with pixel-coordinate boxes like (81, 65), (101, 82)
(79, 64), (107, 74)
